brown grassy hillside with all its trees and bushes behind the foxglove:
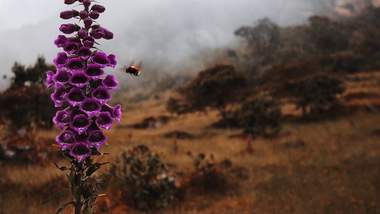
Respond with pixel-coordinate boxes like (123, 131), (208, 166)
(0, 1), (380, 214)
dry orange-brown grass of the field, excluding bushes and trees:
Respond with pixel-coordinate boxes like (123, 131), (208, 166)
(0, 72), (380, 214)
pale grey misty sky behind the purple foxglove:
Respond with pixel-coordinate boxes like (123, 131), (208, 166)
(0, 0), (328, 88)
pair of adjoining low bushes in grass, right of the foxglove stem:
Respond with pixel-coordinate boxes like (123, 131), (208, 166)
(106, 145), (249, 212)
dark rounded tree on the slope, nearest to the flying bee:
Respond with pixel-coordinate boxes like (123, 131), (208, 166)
(180, 65), (246, 119)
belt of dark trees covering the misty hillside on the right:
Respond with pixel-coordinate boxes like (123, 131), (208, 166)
(167, 7), (380, 135)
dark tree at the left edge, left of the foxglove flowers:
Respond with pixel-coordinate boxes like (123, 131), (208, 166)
(0, 57), (54, 134)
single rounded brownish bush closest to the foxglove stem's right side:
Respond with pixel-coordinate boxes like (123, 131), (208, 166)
(110, 145), (178, 211)
